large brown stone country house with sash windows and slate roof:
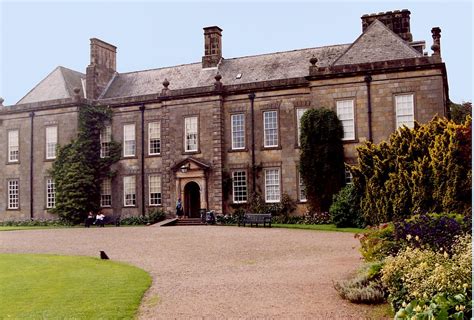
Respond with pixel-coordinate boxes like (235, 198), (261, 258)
(0, 10), (449, 220)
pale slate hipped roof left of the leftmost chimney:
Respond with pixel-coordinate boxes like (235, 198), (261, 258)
(17, 66), (86, 104)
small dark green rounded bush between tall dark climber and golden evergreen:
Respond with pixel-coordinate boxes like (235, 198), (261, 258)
(329, 184), (364, 228)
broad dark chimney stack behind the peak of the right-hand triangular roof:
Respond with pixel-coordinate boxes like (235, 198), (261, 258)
(361, 9), (413, 42)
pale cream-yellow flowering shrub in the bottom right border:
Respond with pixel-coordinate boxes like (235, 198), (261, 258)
(382, 235), (472, 310)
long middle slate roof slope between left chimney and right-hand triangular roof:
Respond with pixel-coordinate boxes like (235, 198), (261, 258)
(101, 44), (349, 98)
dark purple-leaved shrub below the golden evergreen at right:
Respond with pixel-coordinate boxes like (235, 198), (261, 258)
(395, 214), (471, 252)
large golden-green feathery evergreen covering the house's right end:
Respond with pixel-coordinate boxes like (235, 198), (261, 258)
(351, 117), (472, 225)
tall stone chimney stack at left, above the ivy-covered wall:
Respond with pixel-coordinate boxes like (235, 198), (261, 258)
(86, 38), (117, 99)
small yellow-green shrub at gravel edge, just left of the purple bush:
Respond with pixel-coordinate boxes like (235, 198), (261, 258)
(355, 223), (400, 262)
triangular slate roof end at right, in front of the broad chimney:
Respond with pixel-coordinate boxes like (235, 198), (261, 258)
(333, 20), (423, 66)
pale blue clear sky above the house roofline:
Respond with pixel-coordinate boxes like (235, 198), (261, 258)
(0, 0), (473, 105)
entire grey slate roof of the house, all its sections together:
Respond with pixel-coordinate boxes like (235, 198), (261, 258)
(17, 20), (422, 104)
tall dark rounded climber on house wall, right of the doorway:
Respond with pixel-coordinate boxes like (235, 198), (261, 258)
(299, 108), (344, 212)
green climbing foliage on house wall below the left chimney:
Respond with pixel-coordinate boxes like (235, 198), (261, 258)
(51, 105), (121, 223)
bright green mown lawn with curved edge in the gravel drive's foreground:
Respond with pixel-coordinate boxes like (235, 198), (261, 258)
(0, 254), (151, 319)
